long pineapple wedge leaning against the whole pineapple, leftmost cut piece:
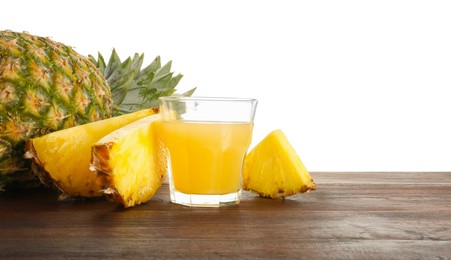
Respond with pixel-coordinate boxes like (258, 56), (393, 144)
(25, 108), (158, 199)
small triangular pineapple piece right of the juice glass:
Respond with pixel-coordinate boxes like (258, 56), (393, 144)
(242, 130), (316, 198)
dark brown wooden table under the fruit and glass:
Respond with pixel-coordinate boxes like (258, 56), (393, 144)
(0, 172), (451, 259)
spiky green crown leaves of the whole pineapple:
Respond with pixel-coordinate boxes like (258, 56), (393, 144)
(89, 49), (196, 115)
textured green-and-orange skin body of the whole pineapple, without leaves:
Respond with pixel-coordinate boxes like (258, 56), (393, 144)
(0, 31), (112, 188)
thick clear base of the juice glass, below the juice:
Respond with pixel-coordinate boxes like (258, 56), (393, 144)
(170, 187), (241, 208)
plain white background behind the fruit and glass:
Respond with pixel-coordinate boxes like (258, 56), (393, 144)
(0, 0), (451, 171)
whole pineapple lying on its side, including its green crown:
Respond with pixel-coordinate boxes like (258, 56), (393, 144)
(0, 31), (194, 189)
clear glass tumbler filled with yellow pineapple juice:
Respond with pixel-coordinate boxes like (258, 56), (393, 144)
(160, 96), (257, 207)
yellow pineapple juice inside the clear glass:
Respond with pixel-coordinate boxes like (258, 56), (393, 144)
(161, 121), (253, 195)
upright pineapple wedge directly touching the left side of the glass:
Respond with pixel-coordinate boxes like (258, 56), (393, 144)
(91, 114), (167, 208)
